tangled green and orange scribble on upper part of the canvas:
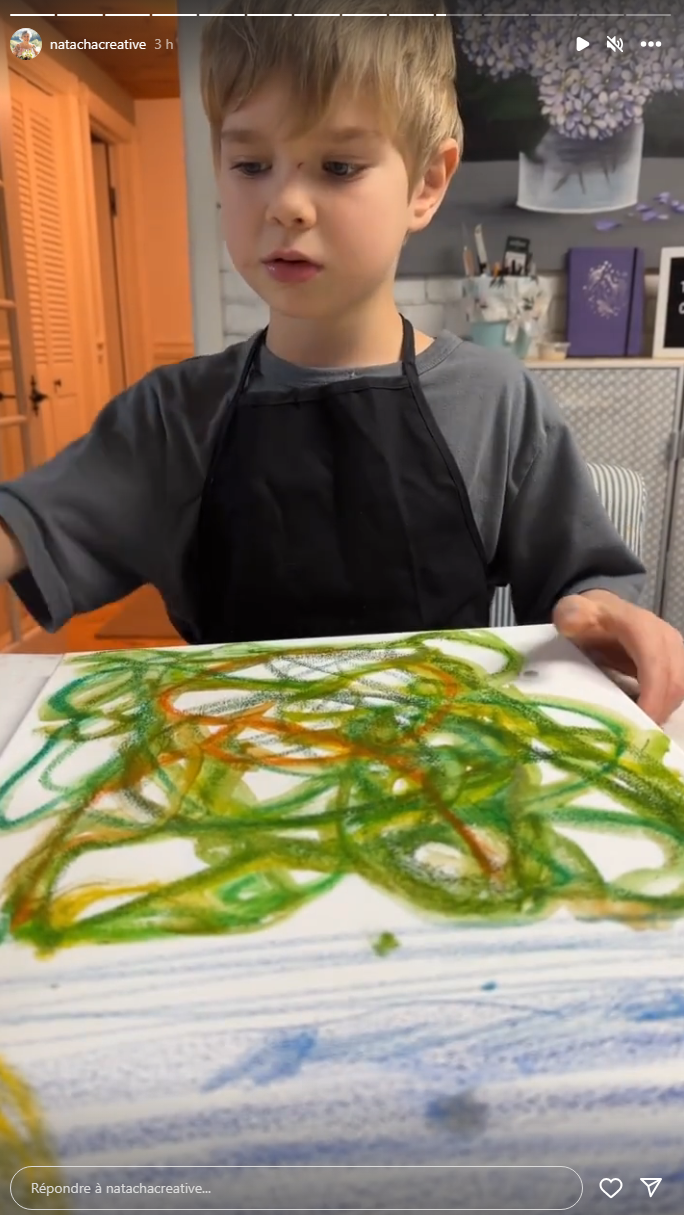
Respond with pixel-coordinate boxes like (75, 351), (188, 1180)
(0, 632), (684, 953)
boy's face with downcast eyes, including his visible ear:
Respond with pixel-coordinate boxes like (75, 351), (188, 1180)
(219, 85), (458, 320)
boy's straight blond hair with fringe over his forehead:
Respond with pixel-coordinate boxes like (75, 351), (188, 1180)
(200, 0), (463, 179)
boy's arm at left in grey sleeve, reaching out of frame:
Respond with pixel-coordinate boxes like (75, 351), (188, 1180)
(0, 373), (199, 632)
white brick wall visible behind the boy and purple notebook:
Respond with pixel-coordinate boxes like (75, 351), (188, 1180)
(216, 245), (657, 356)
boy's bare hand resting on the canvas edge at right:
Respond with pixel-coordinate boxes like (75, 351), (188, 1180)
(553, 590), (684, 725)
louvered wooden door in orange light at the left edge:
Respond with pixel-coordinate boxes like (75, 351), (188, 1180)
(10, 72), (87, 459)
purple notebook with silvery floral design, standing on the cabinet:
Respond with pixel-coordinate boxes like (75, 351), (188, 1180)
(567, 249), (644, 358)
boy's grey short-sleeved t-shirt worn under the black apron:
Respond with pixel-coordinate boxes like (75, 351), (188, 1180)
(0, 332), (645, 642)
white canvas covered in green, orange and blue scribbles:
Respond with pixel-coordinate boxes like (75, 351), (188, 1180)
(0, 628), (684, 1215)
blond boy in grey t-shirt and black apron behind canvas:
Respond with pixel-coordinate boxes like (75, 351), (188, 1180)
(0, 0), (684, 720)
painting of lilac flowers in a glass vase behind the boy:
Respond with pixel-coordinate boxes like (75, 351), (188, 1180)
(398, 8), (684, 277)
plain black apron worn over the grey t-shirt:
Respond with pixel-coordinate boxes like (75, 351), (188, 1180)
(191, 317), (491, 643)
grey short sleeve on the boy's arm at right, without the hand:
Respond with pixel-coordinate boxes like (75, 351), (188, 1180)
(499, 375), (646, 625)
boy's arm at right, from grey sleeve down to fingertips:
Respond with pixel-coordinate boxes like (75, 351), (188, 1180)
(504, 378), (684, 725)
